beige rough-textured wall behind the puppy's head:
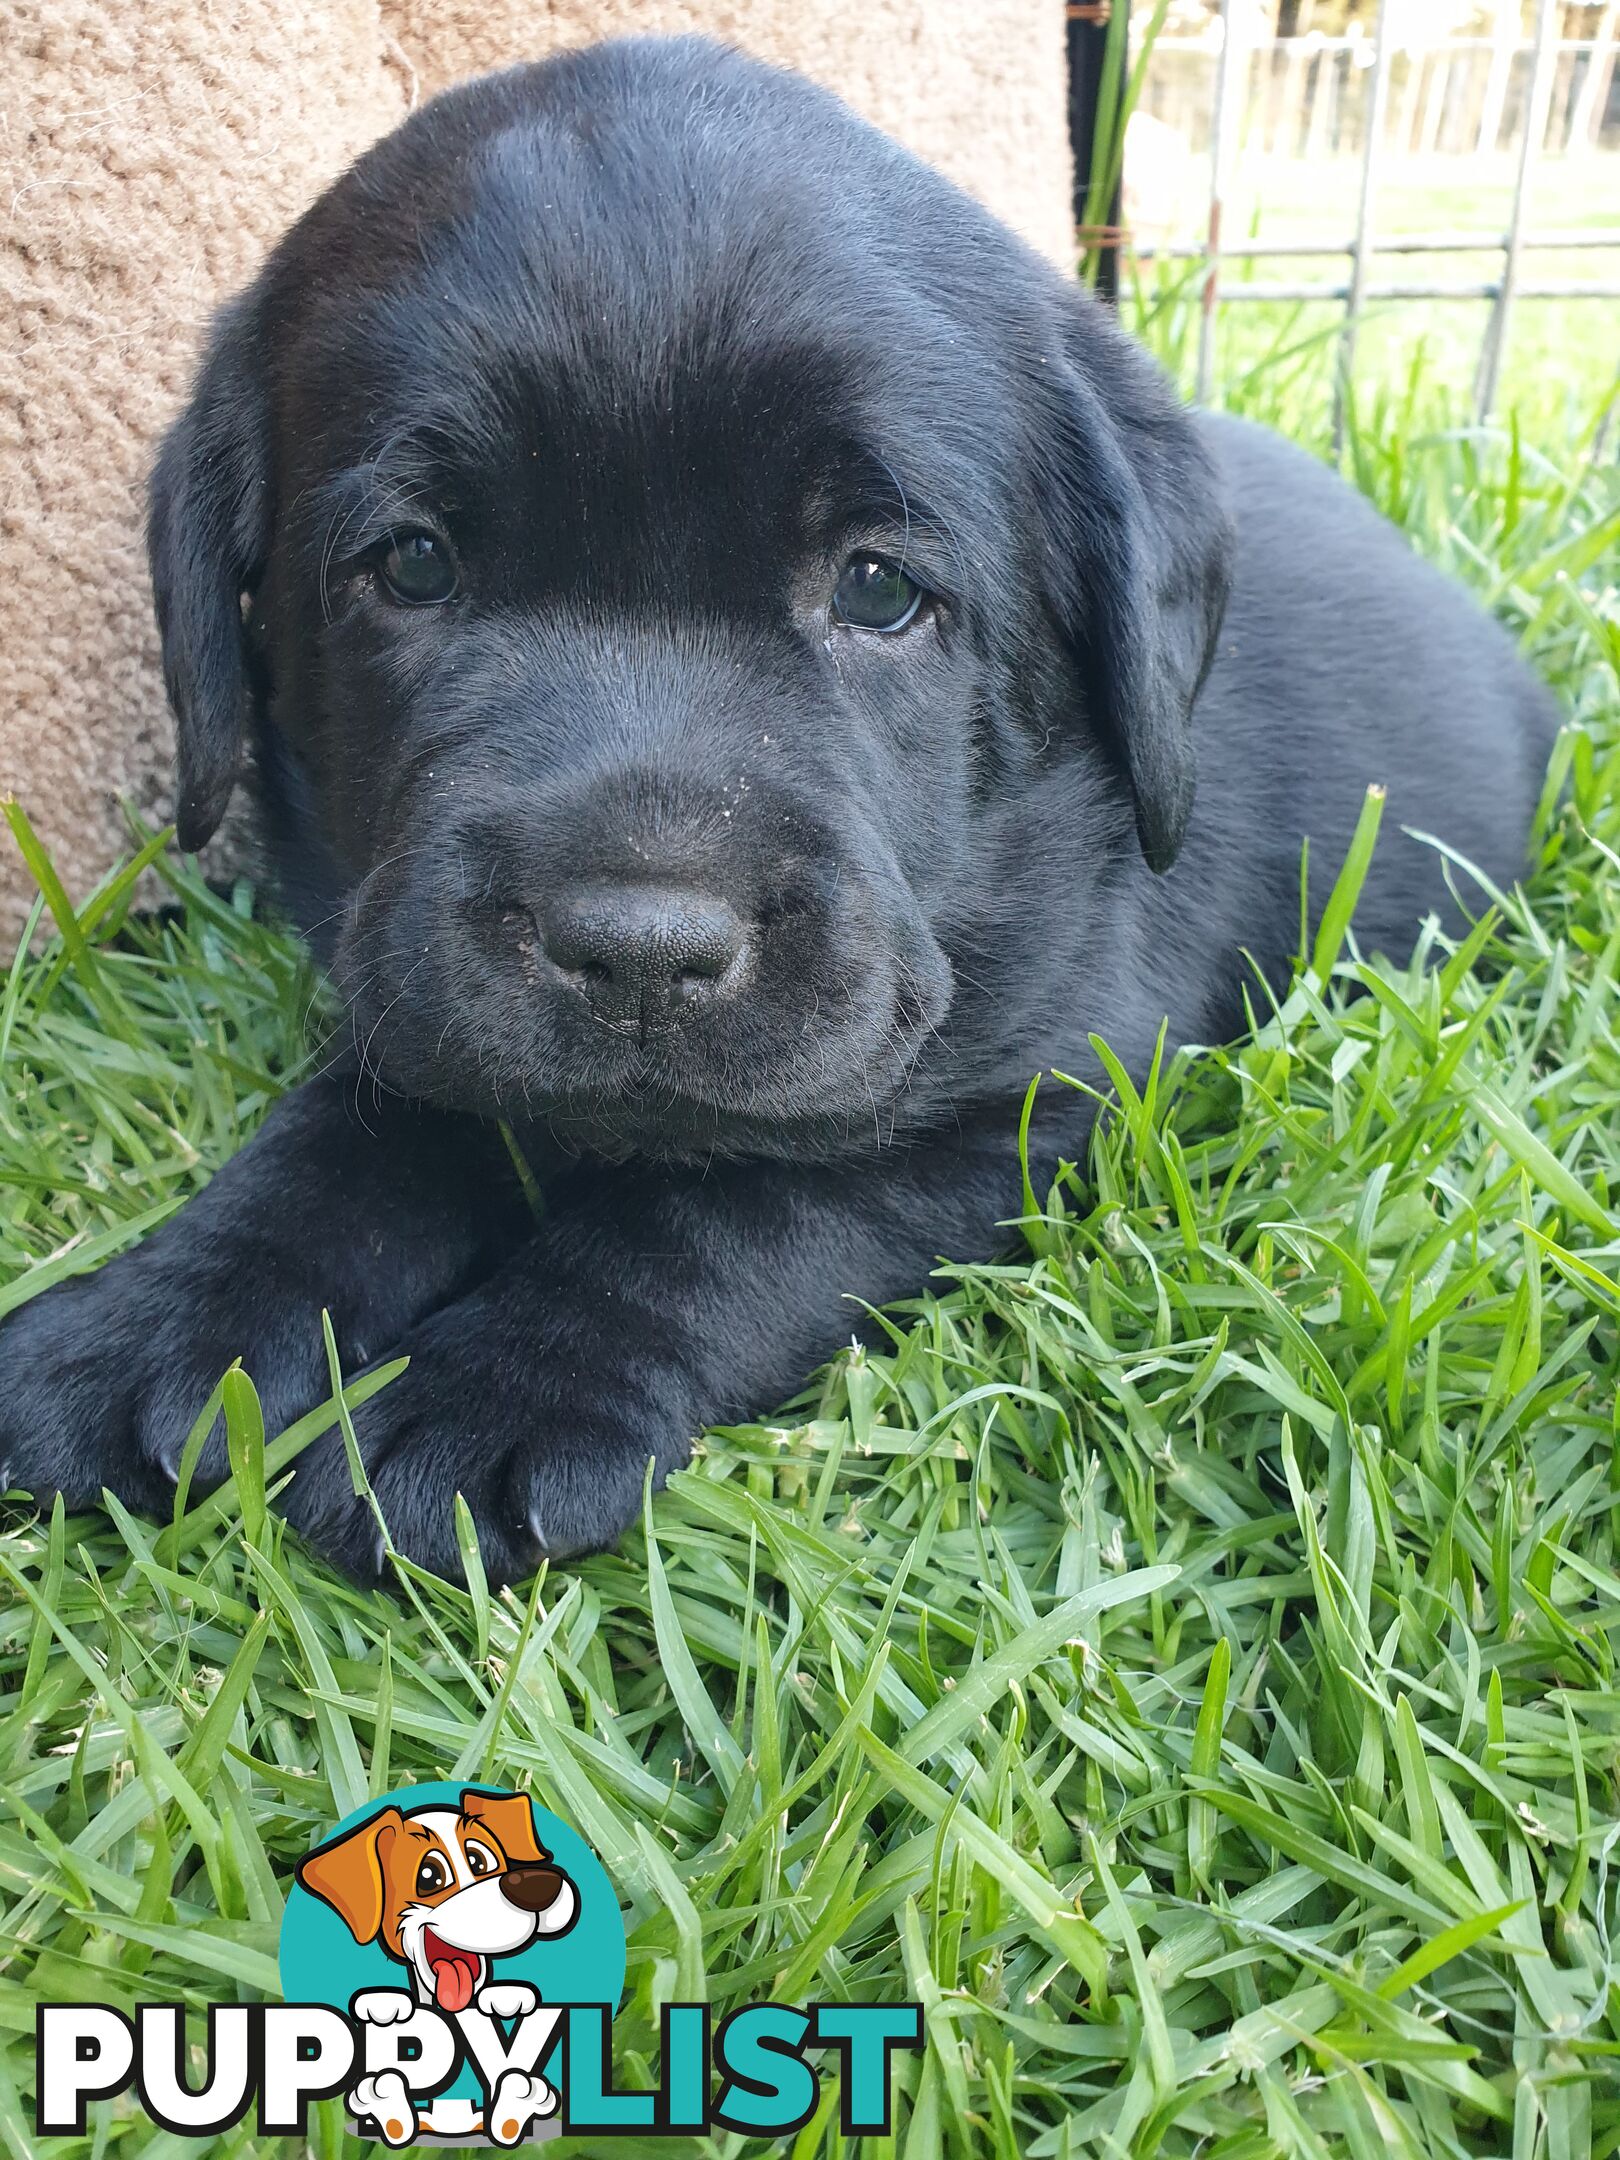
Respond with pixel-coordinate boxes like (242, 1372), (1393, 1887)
(0, 0), (1069, 937)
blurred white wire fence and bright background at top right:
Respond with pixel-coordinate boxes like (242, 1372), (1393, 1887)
(1067, 0), (1620, 434)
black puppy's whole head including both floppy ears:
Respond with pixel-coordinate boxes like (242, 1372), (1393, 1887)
(151, 41), (1225, 1156)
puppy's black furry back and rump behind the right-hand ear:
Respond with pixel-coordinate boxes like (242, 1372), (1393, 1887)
(1164, 415), (1557, 1019)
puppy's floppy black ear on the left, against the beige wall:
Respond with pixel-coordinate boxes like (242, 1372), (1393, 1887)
(147, 294), (270, 849)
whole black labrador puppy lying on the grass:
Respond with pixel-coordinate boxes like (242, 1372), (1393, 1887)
(0, 41), (1553, 1577)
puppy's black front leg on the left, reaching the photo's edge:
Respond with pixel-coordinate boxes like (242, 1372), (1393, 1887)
(0, 1076), (529, 1510)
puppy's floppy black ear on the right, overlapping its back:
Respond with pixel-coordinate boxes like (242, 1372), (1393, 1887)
(1037, 292), (1231, 870)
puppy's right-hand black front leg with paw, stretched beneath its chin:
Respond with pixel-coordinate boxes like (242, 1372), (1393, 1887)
(287, 1112), (1054, 1579)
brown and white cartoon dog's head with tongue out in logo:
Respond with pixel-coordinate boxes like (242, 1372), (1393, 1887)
(296, 1791), (579, 2017)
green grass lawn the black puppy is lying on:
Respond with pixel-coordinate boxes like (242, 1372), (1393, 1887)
(0, 324), (1620, 2160)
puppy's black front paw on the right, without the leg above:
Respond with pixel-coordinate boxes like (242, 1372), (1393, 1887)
(285, 1294), (689, 1583)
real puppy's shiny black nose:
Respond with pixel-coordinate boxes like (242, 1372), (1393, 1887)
(540, 886), (747, 1026)
